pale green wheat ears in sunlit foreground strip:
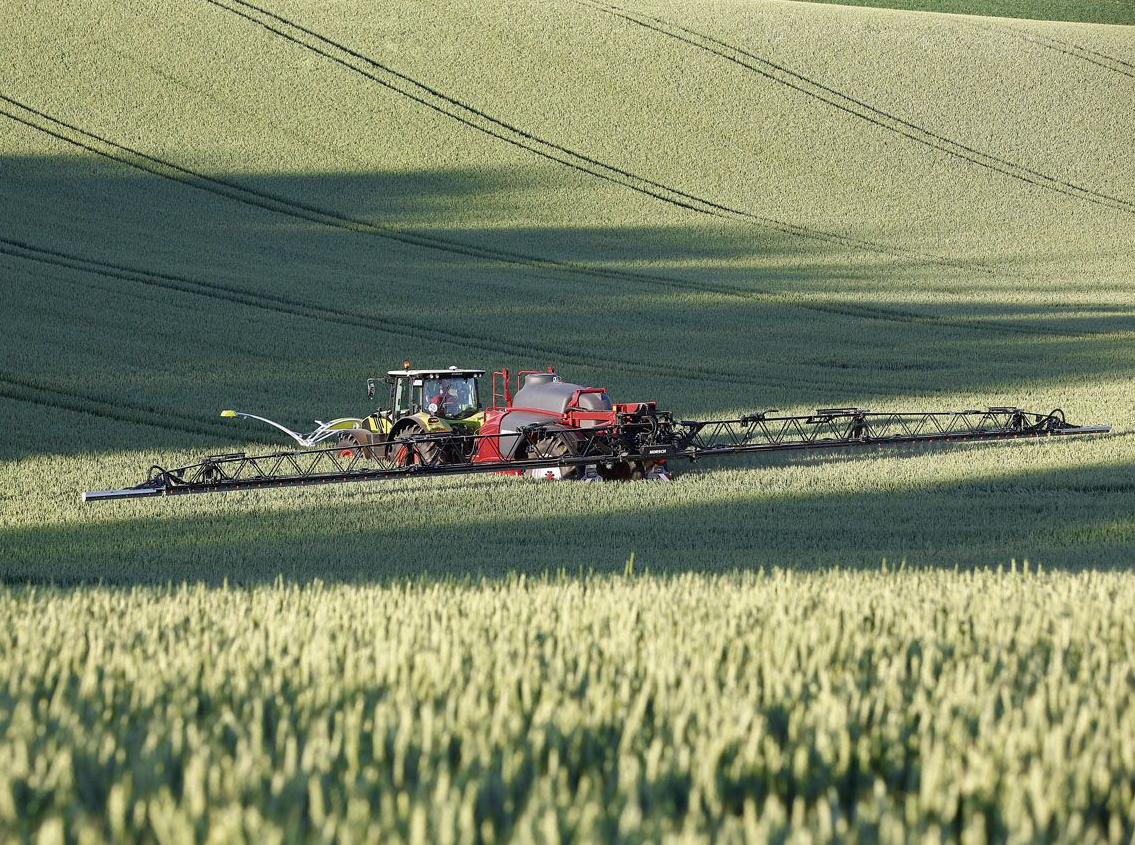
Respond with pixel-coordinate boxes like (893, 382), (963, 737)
(0, 566), (1135, 844)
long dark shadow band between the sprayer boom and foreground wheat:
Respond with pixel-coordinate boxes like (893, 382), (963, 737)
(0, 446), (1135, 586)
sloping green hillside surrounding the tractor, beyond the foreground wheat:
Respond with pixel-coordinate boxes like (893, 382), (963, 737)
(0, 0), (1135, 580)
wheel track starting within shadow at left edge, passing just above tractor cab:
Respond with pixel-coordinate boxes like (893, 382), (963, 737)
(0, 239), (898, 390)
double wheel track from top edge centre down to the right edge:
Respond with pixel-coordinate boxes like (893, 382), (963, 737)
(575, 0), (1135, 214)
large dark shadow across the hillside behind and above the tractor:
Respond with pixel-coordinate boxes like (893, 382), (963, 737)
(0, 156), (1135, 459)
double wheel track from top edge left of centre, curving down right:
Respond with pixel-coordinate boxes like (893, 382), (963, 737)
(197, 0), (993, 273)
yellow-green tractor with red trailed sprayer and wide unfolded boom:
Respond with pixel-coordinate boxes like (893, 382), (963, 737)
(83, 361), (1111, 502)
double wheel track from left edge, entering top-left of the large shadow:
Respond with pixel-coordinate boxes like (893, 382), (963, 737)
(0, 93), (1062, 347)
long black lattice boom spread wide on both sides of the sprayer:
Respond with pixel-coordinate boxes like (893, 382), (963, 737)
(83, 407), (1111, 502)
